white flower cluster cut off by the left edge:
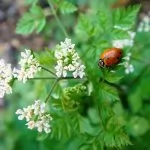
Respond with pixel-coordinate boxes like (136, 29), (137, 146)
(0, 59), (12, 98)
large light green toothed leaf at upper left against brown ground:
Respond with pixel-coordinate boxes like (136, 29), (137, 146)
(16, 6), (46, 35)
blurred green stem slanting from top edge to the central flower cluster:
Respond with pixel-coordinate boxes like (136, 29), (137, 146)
(48, 0), (68, 37)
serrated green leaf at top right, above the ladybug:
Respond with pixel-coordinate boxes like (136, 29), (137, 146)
(114, 5), (140, 29)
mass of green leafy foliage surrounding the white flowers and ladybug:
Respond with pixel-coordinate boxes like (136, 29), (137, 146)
(6, 0), (150, 150)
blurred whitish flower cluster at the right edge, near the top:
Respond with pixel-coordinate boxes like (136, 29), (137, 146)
(137, 12), (150, 32)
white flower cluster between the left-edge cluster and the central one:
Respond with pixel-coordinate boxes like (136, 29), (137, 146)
(13, 49), (41, 83)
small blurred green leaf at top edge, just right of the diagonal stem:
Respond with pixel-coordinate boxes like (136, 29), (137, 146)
(59, 1), (77, 14)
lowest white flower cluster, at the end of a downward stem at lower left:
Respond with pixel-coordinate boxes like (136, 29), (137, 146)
(16, 100), (52, 133)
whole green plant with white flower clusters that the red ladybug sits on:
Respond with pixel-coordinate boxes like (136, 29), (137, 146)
(0, 0), (150, 150)
